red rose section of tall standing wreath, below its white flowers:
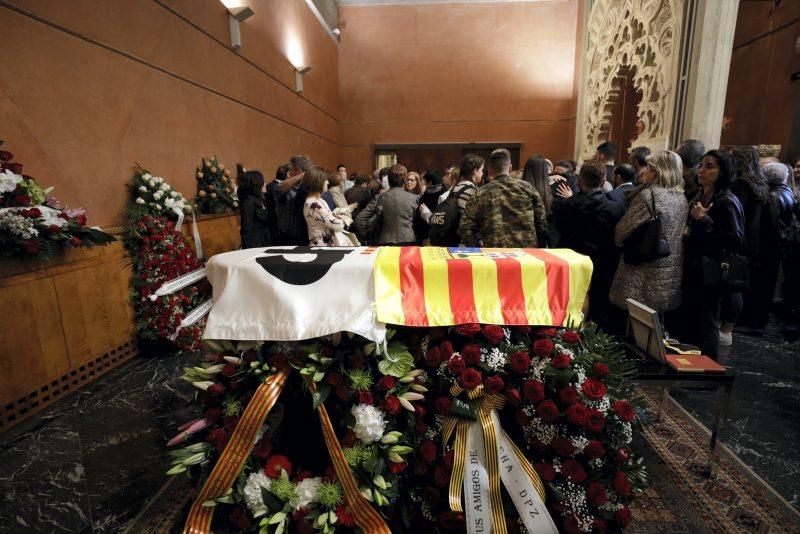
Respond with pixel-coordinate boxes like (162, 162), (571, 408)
(125, 215), (211, 351)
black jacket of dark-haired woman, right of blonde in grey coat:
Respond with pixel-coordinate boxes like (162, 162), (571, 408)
(686, 189), (745, 265)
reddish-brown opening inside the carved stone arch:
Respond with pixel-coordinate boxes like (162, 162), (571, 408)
(606, 65), (642, 163)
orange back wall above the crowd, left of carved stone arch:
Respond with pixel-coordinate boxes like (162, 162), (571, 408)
(339, 0), (579, 171)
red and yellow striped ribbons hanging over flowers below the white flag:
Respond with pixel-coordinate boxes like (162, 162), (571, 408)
(183, 367), (391, 534)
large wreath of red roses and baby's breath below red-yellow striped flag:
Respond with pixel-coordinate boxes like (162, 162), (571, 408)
(408, 324), (646, 532)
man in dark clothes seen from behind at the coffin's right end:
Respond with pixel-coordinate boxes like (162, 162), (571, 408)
(553, 161), (625, 325)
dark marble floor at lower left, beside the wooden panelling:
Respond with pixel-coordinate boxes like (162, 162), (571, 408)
(0, 356), (203, 534)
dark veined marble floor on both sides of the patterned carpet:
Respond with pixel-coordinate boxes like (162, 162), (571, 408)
(0, 320), (800, 534)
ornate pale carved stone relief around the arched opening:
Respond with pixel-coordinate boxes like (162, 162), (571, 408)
(578, 0), (683, 159)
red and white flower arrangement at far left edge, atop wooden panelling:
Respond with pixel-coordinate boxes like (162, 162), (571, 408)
(0, 141), (115, 259)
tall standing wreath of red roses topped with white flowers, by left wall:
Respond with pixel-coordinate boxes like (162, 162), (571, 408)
(125, 169), (211, 351)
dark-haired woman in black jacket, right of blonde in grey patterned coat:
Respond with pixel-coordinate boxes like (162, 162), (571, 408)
(685, 150), (745, 359)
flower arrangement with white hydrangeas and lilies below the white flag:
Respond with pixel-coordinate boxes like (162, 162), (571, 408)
(169, 334), (427, 533)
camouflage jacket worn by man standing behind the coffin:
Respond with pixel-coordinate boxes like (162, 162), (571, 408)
(459, 174), (547, 248)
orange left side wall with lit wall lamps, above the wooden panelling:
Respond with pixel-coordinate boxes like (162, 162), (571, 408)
(0, 0), (341, 226)
